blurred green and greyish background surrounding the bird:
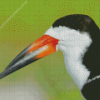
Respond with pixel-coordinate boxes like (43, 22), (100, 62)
(0, 0), (100, 100)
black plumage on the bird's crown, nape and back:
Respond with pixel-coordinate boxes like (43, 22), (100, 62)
(53, 14), (100, 100)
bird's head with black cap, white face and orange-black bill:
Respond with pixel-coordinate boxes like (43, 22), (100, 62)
(0, 15), (95, 78)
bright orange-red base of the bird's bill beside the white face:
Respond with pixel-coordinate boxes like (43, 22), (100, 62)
(27, 35), (59, 59)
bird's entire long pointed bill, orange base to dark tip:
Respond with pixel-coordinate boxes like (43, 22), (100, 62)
(0, 35), (59, 79)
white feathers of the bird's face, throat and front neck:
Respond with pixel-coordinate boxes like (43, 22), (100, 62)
(45, 26), (92, 90)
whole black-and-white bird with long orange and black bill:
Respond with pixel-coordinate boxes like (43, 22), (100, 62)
(0, 14), (100, 100)
